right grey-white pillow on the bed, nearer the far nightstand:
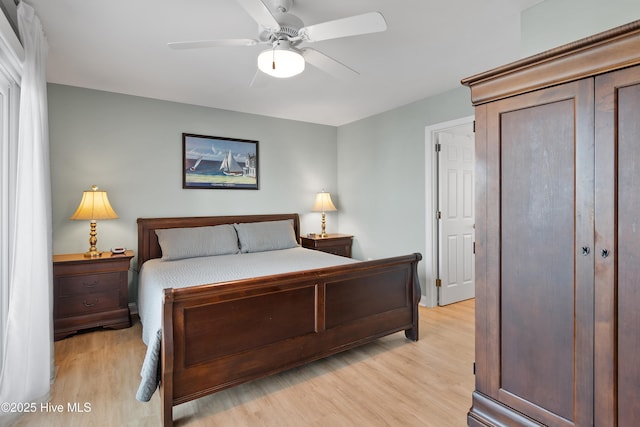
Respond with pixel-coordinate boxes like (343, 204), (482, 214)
(233, 220), (298, 253)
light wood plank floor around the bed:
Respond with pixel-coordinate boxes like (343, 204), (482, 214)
(16, 300), (474, 427)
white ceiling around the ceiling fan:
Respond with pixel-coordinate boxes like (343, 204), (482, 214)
(27, 0), (541, 126)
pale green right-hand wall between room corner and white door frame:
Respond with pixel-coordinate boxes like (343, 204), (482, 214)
(338, 87), (473, 302)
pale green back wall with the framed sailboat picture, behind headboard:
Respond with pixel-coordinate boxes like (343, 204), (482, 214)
(48, 84), (340, 300)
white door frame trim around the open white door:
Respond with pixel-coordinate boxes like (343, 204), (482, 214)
(420, 115), (475, 307)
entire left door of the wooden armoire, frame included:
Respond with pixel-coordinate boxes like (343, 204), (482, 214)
(487, 79), (593, 426)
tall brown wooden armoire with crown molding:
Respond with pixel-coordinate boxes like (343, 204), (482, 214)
(462, 21), (640, 427)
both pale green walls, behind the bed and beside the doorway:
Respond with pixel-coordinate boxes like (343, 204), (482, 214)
(48, 84), (472, 301)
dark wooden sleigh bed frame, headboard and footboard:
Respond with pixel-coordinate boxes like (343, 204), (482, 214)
(138, 214), (422, 426)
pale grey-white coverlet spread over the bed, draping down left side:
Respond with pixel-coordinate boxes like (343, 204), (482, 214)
(137, 247), (357, 401)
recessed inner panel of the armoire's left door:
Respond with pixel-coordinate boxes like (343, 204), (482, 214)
(501, 99), (576, 419)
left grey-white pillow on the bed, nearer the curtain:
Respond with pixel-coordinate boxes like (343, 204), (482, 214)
(156, 224), (239, 261)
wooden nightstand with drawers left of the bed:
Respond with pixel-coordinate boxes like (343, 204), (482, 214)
(53, 251), (133, 341)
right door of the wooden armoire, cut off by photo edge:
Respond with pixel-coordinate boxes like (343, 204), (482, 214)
(595, 67), (640, 427)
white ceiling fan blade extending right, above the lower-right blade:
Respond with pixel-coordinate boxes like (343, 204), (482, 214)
(298, 12), (387, 42)
